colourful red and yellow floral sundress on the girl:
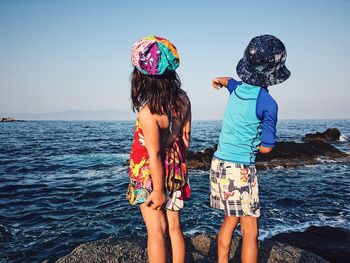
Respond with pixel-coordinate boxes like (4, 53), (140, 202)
(126, 119), (191, 211)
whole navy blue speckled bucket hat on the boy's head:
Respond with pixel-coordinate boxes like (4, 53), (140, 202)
(236, 35), (290, 87)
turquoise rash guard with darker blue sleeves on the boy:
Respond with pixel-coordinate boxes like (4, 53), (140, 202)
(214, 79), (278, 164)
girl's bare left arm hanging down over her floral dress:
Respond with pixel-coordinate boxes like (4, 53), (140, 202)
(139, 106), (166, 210)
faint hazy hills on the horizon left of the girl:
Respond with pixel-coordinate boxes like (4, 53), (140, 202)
(0, 109), (135, 121)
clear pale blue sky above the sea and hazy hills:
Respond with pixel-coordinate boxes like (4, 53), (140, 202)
(0, 0), (350, 119)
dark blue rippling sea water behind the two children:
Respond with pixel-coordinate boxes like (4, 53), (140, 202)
(0, 120), (350, 262)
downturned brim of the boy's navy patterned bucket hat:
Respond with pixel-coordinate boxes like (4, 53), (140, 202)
(236, 59), (290, 87)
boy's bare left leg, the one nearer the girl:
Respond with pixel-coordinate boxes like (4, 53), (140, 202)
(218, 216), (239, 263)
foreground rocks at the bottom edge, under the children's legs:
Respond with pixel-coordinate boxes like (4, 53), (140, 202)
(50, 226), (350, 263)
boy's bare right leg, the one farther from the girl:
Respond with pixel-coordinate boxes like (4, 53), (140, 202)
(241, 216), (258, 263)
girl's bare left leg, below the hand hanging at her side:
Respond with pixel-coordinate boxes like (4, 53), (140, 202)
(140, 205), (166, 263)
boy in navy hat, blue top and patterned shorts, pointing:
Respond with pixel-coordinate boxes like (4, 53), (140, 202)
(210, 35), (290, 263)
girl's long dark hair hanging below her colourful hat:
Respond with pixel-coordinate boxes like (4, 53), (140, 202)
(131, 68), (184, 115)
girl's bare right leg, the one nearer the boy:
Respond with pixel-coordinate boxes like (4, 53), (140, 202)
(166, 210), (185, 263)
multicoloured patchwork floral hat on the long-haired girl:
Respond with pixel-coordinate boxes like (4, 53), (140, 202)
(131, 36), (180, 75)
